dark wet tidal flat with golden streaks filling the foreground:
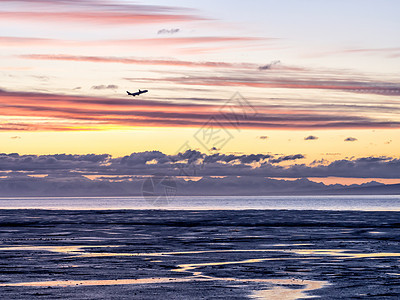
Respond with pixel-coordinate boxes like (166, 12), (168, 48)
(0, 210), (400, 299)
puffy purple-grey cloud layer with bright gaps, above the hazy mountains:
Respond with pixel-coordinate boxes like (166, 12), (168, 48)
(0, 150), (400, 178)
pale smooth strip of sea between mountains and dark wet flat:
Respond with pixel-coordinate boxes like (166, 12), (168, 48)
(0, 195), (400, 211)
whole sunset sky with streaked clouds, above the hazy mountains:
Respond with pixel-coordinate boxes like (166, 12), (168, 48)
(0, 0), (400, 191)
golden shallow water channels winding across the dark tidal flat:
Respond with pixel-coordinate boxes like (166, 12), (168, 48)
(0, 244), (400, 300)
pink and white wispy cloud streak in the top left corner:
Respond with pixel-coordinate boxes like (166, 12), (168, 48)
(0, 0), (205, 25)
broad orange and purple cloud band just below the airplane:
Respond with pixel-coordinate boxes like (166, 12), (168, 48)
(0, 90), (400, 130)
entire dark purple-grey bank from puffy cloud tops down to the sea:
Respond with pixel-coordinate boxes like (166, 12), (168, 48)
(0, 150), (400, 197)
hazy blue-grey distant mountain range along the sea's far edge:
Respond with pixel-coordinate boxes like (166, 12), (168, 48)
(0, 176), (400, 197)
